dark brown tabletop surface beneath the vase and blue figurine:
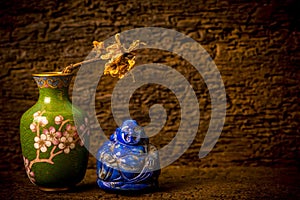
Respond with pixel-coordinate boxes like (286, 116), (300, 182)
(0, 166), (300, 199)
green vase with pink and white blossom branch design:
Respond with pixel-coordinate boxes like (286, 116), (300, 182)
(20, 72), (89, 191)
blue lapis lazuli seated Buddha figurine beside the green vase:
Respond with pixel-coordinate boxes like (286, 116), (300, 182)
(97, 120), (160, 191)
